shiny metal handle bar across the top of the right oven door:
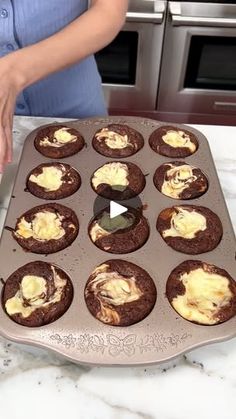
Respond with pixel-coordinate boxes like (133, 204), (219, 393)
(169, 3), (236, 28)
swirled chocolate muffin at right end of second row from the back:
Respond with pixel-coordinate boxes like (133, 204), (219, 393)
(153, 161), (208, 199)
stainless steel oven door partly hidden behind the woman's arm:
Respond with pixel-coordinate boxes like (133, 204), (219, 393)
(95, 0), (165, 113)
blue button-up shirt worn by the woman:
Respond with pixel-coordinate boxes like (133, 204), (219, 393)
(0, 0), (106, 118)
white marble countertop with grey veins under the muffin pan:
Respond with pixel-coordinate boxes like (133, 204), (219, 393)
(0, 117), (236, 419)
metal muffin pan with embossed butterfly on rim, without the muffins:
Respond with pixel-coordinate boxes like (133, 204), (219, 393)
(0, 117), (236, 365)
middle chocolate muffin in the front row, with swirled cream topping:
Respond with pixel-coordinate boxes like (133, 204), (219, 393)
(85, 259), (157, 326)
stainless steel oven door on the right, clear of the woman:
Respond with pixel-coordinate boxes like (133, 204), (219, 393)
(158, 2), (236, 122)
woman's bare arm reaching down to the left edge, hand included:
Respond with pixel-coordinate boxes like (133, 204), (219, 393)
(0, 0), (128, 172)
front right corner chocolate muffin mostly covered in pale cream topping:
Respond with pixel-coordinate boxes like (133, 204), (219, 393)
(166, 260), (236, 325)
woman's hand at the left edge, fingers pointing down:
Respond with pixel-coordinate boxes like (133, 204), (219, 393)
(0, 53), (23, 173)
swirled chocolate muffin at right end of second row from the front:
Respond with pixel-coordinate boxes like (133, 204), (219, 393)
(157, 205), (223, 255)
